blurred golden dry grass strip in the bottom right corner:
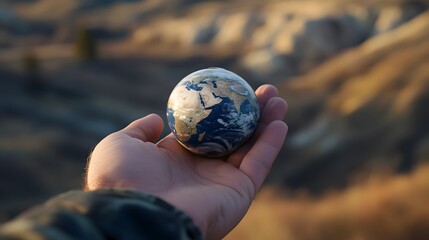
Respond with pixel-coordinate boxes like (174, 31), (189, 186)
(225, 165), (429, 240)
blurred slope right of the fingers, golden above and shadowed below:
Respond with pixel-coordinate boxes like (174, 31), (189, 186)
(279, 9), (429, 189)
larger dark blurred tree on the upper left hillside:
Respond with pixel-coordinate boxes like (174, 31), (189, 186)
(74, 27), (97, 60)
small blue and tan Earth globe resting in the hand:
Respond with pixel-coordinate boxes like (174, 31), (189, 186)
(167, 68), (260, 157)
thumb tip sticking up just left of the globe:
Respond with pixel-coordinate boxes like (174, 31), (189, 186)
(119, 114), (164, 142)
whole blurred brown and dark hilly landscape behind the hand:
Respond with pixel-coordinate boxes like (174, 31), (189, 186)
(0, 0), (429, 240)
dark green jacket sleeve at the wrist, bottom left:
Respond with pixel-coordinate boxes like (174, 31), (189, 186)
(0, 189), (202, 240)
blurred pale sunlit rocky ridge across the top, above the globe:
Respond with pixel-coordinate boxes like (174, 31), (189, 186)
(0, 0), (428, 74)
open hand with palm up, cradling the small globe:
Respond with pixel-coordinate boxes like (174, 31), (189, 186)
(86, 85), (287, 239)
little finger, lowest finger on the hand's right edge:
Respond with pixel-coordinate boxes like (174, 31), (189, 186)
(239, 120), (288, 193)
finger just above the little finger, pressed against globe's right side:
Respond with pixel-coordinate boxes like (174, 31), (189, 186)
(227, 97), (288, 168)
